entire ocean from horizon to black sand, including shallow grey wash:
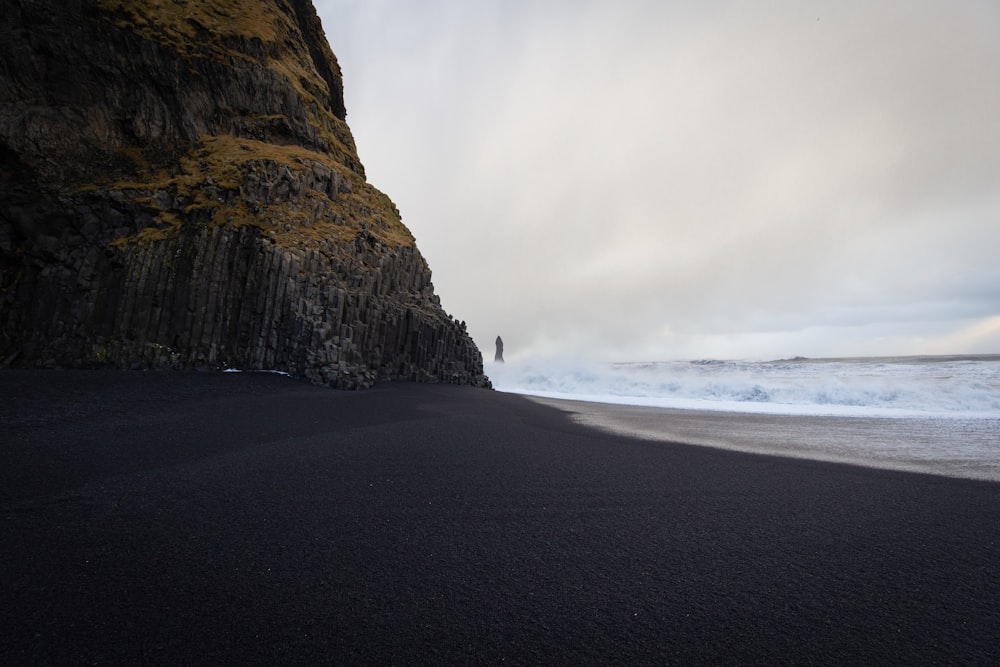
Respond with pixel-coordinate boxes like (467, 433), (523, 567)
(486, 355), (1000, 480)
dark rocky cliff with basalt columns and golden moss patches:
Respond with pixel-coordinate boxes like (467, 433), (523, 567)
(0, 0), (488, 388)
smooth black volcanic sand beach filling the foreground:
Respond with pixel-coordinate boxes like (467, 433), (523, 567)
(0, 371), (1000, 665)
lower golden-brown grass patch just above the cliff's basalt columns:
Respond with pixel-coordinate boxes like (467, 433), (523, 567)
(101, 136), (415, 251)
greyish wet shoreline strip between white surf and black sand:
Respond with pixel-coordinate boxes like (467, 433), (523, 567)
(519, 394), (1000, 482)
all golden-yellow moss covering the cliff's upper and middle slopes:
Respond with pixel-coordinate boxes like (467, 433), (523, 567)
(90, 0), (414, 258)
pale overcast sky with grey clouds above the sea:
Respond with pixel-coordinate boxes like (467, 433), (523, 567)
(316, 0), (1000, 361)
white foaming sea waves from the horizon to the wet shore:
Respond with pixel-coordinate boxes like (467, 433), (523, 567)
(487, 355), (1000, 419)
